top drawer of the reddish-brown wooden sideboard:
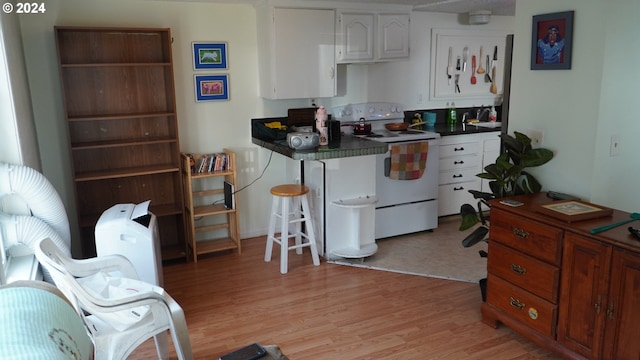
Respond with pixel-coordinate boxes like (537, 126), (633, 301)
(489, 207), (562, 266)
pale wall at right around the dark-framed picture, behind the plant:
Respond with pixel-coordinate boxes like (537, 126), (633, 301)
(509, 0), (640, 212)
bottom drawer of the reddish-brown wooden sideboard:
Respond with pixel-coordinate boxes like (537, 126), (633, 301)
(487, 276), (558, 339)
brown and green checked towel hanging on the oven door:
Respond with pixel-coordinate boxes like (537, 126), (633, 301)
(389, 141), (429, 180)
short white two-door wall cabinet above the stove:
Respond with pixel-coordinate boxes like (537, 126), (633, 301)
(336, 10), (409, 63)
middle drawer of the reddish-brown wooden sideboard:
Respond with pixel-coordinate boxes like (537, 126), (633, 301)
(487, 241), (560, 304)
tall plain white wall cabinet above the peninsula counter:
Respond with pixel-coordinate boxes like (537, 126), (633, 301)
(256, 5), (336, 99)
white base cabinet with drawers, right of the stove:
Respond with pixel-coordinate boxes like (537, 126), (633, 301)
(438, 131), (500, 216)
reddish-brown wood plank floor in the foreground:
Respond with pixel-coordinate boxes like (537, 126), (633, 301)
(130, 237), (559, 360)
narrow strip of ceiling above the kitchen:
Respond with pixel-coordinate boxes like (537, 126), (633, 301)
(337, 0), (516, 16)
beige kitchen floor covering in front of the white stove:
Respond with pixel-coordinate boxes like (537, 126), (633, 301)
(329, 217), (487, 283)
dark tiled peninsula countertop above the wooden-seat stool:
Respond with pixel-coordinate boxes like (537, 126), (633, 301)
(251, 135), (389, 160)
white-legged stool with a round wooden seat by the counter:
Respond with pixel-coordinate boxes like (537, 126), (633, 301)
(264, 184), (320, 274)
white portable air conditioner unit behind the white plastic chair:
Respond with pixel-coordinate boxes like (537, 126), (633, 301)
(95, 201), (163, 287)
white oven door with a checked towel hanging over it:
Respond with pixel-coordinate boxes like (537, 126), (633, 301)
(376, 139), (440, 208)
